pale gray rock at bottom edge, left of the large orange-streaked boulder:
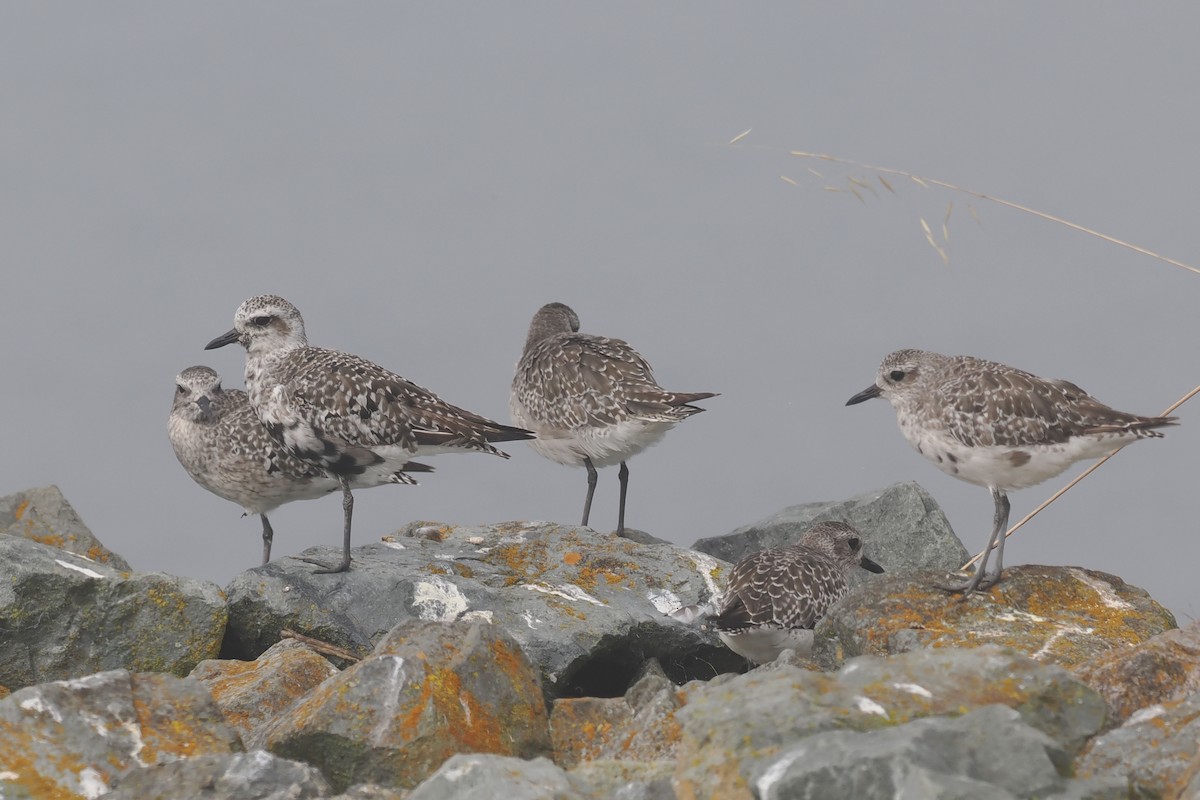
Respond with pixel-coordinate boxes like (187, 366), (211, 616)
(104, 750), (329, 800)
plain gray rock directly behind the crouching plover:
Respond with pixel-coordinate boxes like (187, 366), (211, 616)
(692, 482), (968, 587)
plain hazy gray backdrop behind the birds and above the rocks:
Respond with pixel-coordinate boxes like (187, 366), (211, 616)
(0, 1), (1200, 622)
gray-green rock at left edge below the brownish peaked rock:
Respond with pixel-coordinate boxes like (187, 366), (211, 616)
(0, 535), (227, 690)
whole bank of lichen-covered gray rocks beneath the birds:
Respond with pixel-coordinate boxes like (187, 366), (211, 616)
(0, 483), (1200, 800)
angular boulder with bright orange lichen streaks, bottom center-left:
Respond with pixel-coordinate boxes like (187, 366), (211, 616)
(264, 620), (550, 790)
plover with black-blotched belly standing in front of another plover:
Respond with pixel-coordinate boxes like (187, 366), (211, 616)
(204, 295), (533, 572)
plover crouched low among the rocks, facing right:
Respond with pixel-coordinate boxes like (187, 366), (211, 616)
(709, 522), (883, 664)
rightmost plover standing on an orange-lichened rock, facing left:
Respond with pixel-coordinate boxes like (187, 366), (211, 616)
(846, 350), (1176, 596)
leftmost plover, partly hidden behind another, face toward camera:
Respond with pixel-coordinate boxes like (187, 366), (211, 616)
(167, 366), (432, 564)
